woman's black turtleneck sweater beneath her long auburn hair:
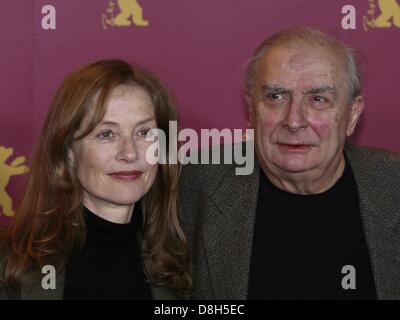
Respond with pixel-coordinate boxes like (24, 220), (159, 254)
(64, 205), (152, 300)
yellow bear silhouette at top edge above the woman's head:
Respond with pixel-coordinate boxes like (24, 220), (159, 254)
(102, 0), (149, 29)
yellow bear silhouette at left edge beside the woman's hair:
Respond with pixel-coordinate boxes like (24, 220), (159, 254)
(0, 146), (29, 217)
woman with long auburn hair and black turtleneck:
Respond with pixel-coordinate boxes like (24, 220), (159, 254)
(0, 60), (191, 299)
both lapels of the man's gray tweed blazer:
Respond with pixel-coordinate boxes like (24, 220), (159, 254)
(203, 143), (400, 299)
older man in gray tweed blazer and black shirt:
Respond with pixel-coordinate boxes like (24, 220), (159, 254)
(181, 27), (400, 299)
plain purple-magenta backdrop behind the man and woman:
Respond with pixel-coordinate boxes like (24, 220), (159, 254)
(0, 0), (400, 223)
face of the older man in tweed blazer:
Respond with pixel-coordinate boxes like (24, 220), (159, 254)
(247, 45), (363, 174)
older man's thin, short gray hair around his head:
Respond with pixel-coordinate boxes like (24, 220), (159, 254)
(244, 26), (361, 102)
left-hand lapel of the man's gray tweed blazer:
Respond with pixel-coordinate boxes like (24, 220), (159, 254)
(202, 163), (259, 299)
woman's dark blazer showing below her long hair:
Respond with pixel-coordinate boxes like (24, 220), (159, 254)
(0, 257), (178, 300)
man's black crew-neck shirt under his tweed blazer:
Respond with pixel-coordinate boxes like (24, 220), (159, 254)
(248, 160), (376, 299)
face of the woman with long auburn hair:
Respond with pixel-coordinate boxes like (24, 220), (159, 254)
(71, 85), (157, 215)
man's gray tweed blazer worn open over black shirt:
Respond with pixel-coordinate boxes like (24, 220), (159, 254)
(181, 144), (400, 299)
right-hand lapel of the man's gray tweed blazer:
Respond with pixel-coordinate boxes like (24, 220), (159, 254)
(345, 145), (400, 299)
